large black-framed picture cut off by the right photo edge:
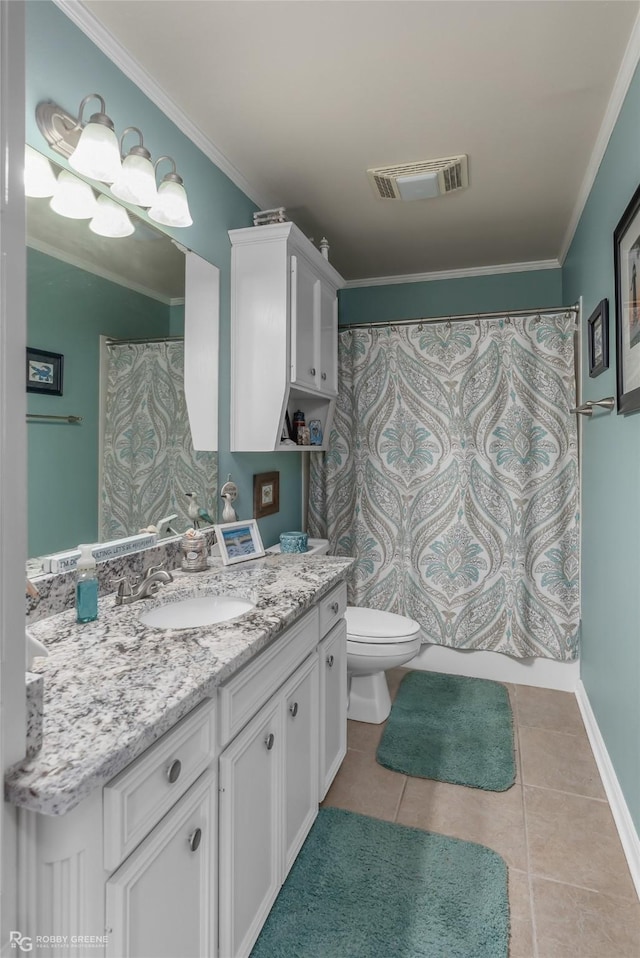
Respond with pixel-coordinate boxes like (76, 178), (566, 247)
(613, 186), (640, 416)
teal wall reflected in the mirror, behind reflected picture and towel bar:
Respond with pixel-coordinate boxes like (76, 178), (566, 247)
(27, 249), (169, 556)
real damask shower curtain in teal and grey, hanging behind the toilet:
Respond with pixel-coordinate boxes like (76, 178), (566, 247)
(309, 312), (579, 660)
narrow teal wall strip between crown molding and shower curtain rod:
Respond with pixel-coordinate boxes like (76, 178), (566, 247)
(340, 268), (569, 326)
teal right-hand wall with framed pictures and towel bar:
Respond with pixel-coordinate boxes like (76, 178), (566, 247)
(563, 63), (640, 831)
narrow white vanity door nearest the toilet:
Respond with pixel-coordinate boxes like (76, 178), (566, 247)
(319, 619), (347, 801)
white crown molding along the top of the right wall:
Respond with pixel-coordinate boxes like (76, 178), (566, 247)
(558, 5), (640, 266)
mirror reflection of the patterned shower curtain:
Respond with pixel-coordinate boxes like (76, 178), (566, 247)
(100, 340), (217, 541)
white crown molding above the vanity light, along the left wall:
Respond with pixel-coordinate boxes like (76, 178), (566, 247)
(53, 0), (275, 209)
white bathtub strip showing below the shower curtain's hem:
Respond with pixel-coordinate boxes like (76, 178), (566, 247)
(406, 645), (580, 692)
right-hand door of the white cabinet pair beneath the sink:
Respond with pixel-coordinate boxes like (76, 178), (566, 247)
(282, 653), (319, 879)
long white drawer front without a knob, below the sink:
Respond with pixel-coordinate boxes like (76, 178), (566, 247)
(218, 609), (320, 747)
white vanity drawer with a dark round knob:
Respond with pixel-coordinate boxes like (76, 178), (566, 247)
(103, 699), (216, 871)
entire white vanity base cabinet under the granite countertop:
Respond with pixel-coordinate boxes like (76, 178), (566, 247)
(18, 584), (346, 958)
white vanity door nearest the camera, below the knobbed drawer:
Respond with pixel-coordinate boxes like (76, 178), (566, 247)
(106, 770), (217, 958)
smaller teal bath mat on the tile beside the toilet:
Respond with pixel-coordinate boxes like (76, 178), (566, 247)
(376, 672), (516, 792)
